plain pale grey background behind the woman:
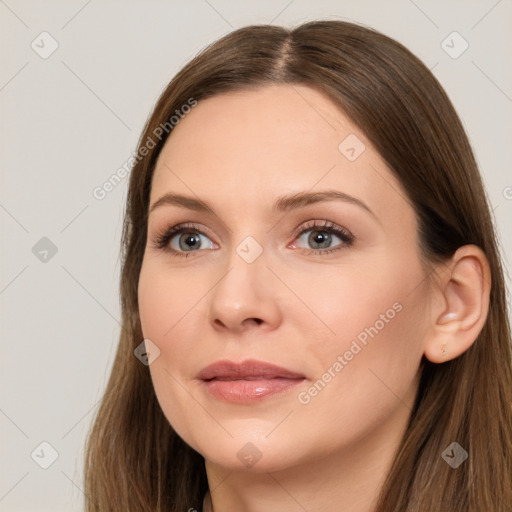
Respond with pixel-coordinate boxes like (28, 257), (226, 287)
(0, 0), (512, 512)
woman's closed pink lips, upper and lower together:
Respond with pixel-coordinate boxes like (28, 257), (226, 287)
(197, 359), (305, 404)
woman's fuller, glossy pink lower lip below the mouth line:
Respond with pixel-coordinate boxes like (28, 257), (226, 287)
(203, 378), (304, 403)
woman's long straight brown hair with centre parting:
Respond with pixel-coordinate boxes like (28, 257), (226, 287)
(85, 21), (512, 512)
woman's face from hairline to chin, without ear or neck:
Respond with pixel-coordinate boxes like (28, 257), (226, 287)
(139, 85), (428, 471)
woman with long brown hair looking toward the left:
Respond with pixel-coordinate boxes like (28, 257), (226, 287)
(85, 21), (512, 512)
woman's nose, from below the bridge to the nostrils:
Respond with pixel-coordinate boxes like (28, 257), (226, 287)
(208, 243), (282, 334)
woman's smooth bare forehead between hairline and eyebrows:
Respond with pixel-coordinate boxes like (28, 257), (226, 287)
(150, 84), (411, 226)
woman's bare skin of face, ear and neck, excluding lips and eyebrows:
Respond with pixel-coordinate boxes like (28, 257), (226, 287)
(139, 85), (490, 512)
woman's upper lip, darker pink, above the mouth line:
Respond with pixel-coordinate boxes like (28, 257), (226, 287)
(197, 359), (305, 380)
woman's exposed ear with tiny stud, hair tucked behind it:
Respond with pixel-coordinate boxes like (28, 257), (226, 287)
(424, 245), (491, 363)
